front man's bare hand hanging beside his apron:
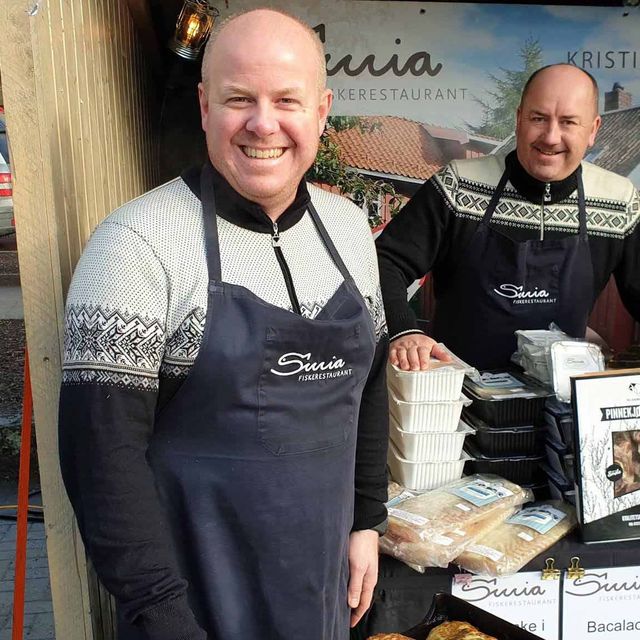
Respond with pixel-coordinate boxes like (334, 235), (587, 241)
(348, 529), (378, 627)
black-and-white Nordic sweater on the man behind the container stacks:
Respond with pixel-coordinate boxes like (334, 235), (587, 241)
(376, 152), (640, 340)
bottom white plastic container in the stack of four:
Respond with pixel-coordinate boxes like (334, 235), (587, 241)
(387, 442), (469, 491)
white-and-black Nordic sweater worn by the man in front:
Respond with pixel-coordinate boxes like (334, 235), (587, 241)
(59, 170), (388, 640)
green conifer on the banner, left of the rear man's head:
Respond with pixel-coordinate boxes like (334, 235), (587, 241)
(469, 38), (542, 140)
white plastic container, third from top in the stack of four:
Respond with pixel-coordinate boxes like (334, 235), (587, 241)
(389, 416), (476, 462)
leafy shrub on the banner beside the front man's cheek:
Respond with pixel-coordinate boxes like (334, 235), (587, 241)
(307, 116), (401, 228)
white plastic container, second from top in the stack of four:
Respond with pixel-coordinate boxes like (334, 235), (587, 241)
(389, 387), (471, 433)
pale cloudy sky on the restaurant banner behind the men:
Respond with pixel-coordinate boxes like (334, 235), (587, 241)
(219, 0), (640, 130)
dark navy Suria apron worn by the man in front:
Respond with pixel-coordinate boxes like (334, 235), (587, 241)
(121, 166), (375, 640)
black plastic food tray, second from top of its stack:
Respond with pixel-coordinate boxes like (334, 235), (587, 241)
(463, 411), (546, 458)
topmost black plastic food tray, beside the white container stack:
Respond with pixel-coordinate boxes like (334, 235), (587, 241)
(463, 371), (550, 427)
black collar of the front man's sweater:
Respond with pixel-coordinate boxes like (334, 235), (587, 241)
(180, 165), (311, 233)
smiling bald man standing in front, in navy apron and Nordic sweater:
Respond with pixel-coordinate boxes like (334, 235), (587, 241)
(60, 9), (388, 640)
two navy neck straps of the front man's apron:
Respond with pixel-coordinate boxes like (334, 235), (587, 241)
(200, 163), (353, 282)
